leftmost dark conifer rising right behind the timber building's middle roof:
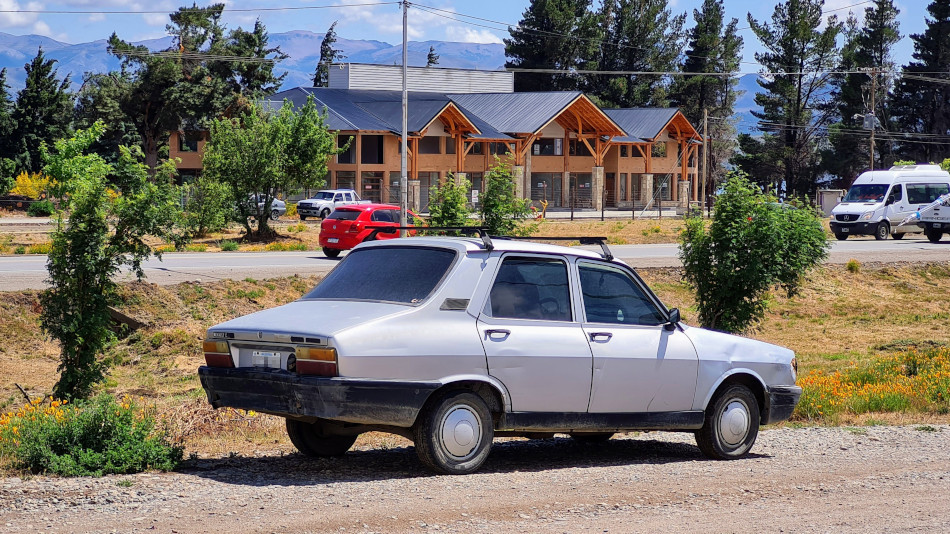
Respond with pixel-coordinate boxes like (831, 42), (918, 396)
(505, 0), (600, 92)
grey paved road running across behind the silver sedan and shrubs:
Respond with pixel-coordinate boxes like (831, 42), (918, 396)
(0, 238), (950, 291)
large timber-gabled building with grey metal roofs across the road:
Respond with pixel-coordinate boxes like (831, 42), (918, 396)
(170, 65), (701, 211)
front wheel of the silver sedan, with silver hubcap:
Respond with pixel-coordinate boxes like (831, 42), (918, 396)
(696, 384), (760, 460)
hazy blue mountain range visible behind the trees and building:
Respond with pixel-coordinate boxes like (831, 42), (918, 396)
(0, 30), (759, 132)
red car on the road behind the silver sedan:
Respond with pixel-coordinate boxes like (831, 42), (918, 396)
(320, 204), (423, 258)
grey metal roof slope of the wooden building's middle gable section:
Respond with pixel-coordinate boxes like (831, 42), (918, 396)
(448, 91), (581, 134)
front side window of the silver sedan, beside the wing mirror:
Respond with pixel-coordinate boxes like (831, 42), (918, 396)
(578, 263), (666, 325)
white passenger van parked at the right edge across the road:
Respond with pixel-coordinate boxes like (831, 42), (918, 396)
(831, 165), (950, 240)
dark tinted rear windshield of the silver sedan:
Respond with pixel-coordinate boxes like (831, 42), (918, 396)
(303, 247), (455, 304)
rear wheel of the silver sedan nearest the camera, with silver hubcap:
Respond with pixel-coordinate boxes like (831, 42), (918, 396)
(414, 390), (495, 475)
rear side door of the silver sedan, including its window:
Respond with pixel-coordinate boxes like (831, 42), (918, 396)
(478, 255), (591, 413)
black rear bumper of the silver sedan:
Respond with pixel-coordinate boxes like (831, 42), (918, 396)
(198, 366), (442, 428)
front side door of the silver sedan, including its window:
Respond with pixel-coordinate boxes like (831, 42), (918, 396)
(577, 260), (699, 413)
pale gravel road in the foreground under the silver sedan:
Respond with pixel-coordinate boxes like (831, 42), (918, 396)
(0, 425), (950, 533)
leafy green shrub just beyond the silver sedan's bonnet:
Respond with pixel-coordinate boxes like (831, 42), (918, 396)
(679, 173), (829, 332)
